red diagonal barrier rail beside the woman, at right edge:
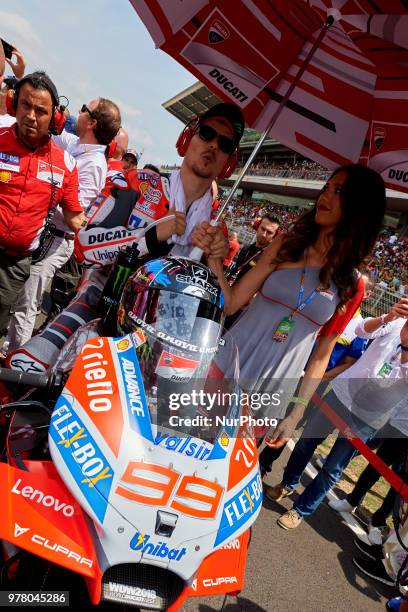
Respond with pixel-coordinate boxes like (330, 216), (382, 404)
(312, 393), (408, 501)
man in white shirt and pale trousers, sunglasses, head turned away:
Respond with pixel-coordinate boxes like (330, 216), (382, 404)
(3, 98), (121, 352)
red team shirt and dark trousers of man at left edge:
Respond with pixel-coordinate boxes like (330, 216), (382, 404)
(0, 125), (82, 329)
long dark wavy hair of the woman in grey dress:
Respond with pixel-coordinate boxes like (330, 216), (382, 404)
(274, 164), (386, 305)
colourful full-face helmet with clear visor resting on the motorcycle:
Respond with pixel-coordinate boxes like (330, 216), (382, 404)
(118, 257), (224, 353)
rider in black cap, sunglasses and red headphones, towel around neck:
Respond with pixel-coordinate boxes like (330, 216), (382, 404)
(6, 103), (245, 371)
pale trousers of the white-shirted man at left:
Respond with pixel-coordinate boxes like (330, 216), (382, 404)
(4, 236), (74, 353)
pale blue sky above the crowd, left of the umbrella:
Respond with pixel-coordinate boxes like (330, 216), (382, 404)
(0, 0), (196, 164)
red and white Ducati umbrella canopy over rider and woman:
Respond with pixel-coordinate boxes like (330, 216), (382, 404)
(131, 0), (408, 191)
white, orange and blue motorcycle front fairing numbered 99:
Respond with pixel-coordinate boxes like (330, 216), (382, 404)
(4, 329), (262, 607)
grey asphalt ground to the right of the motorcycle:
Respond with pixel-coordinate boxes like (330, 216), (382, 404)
(182, 450), (397, 612)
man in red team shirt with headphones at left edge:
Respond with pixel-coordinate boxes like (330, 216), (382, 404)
(0, 72), (84, 338)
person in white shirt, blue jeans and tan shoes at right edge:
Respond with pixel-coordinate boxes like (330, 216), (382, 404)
(265, 298), (408, 529)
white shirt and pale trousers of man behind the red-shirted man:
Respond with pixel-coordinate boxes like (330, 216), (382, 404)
(6, 130), (107, 351)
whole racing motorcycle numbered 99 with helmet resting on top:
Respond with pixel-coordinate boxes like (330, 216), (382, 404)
(0, 257), (262, 611)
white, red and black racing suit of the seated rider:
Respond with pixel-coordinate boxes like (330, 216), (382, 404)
(6, 171), (213, 371)
